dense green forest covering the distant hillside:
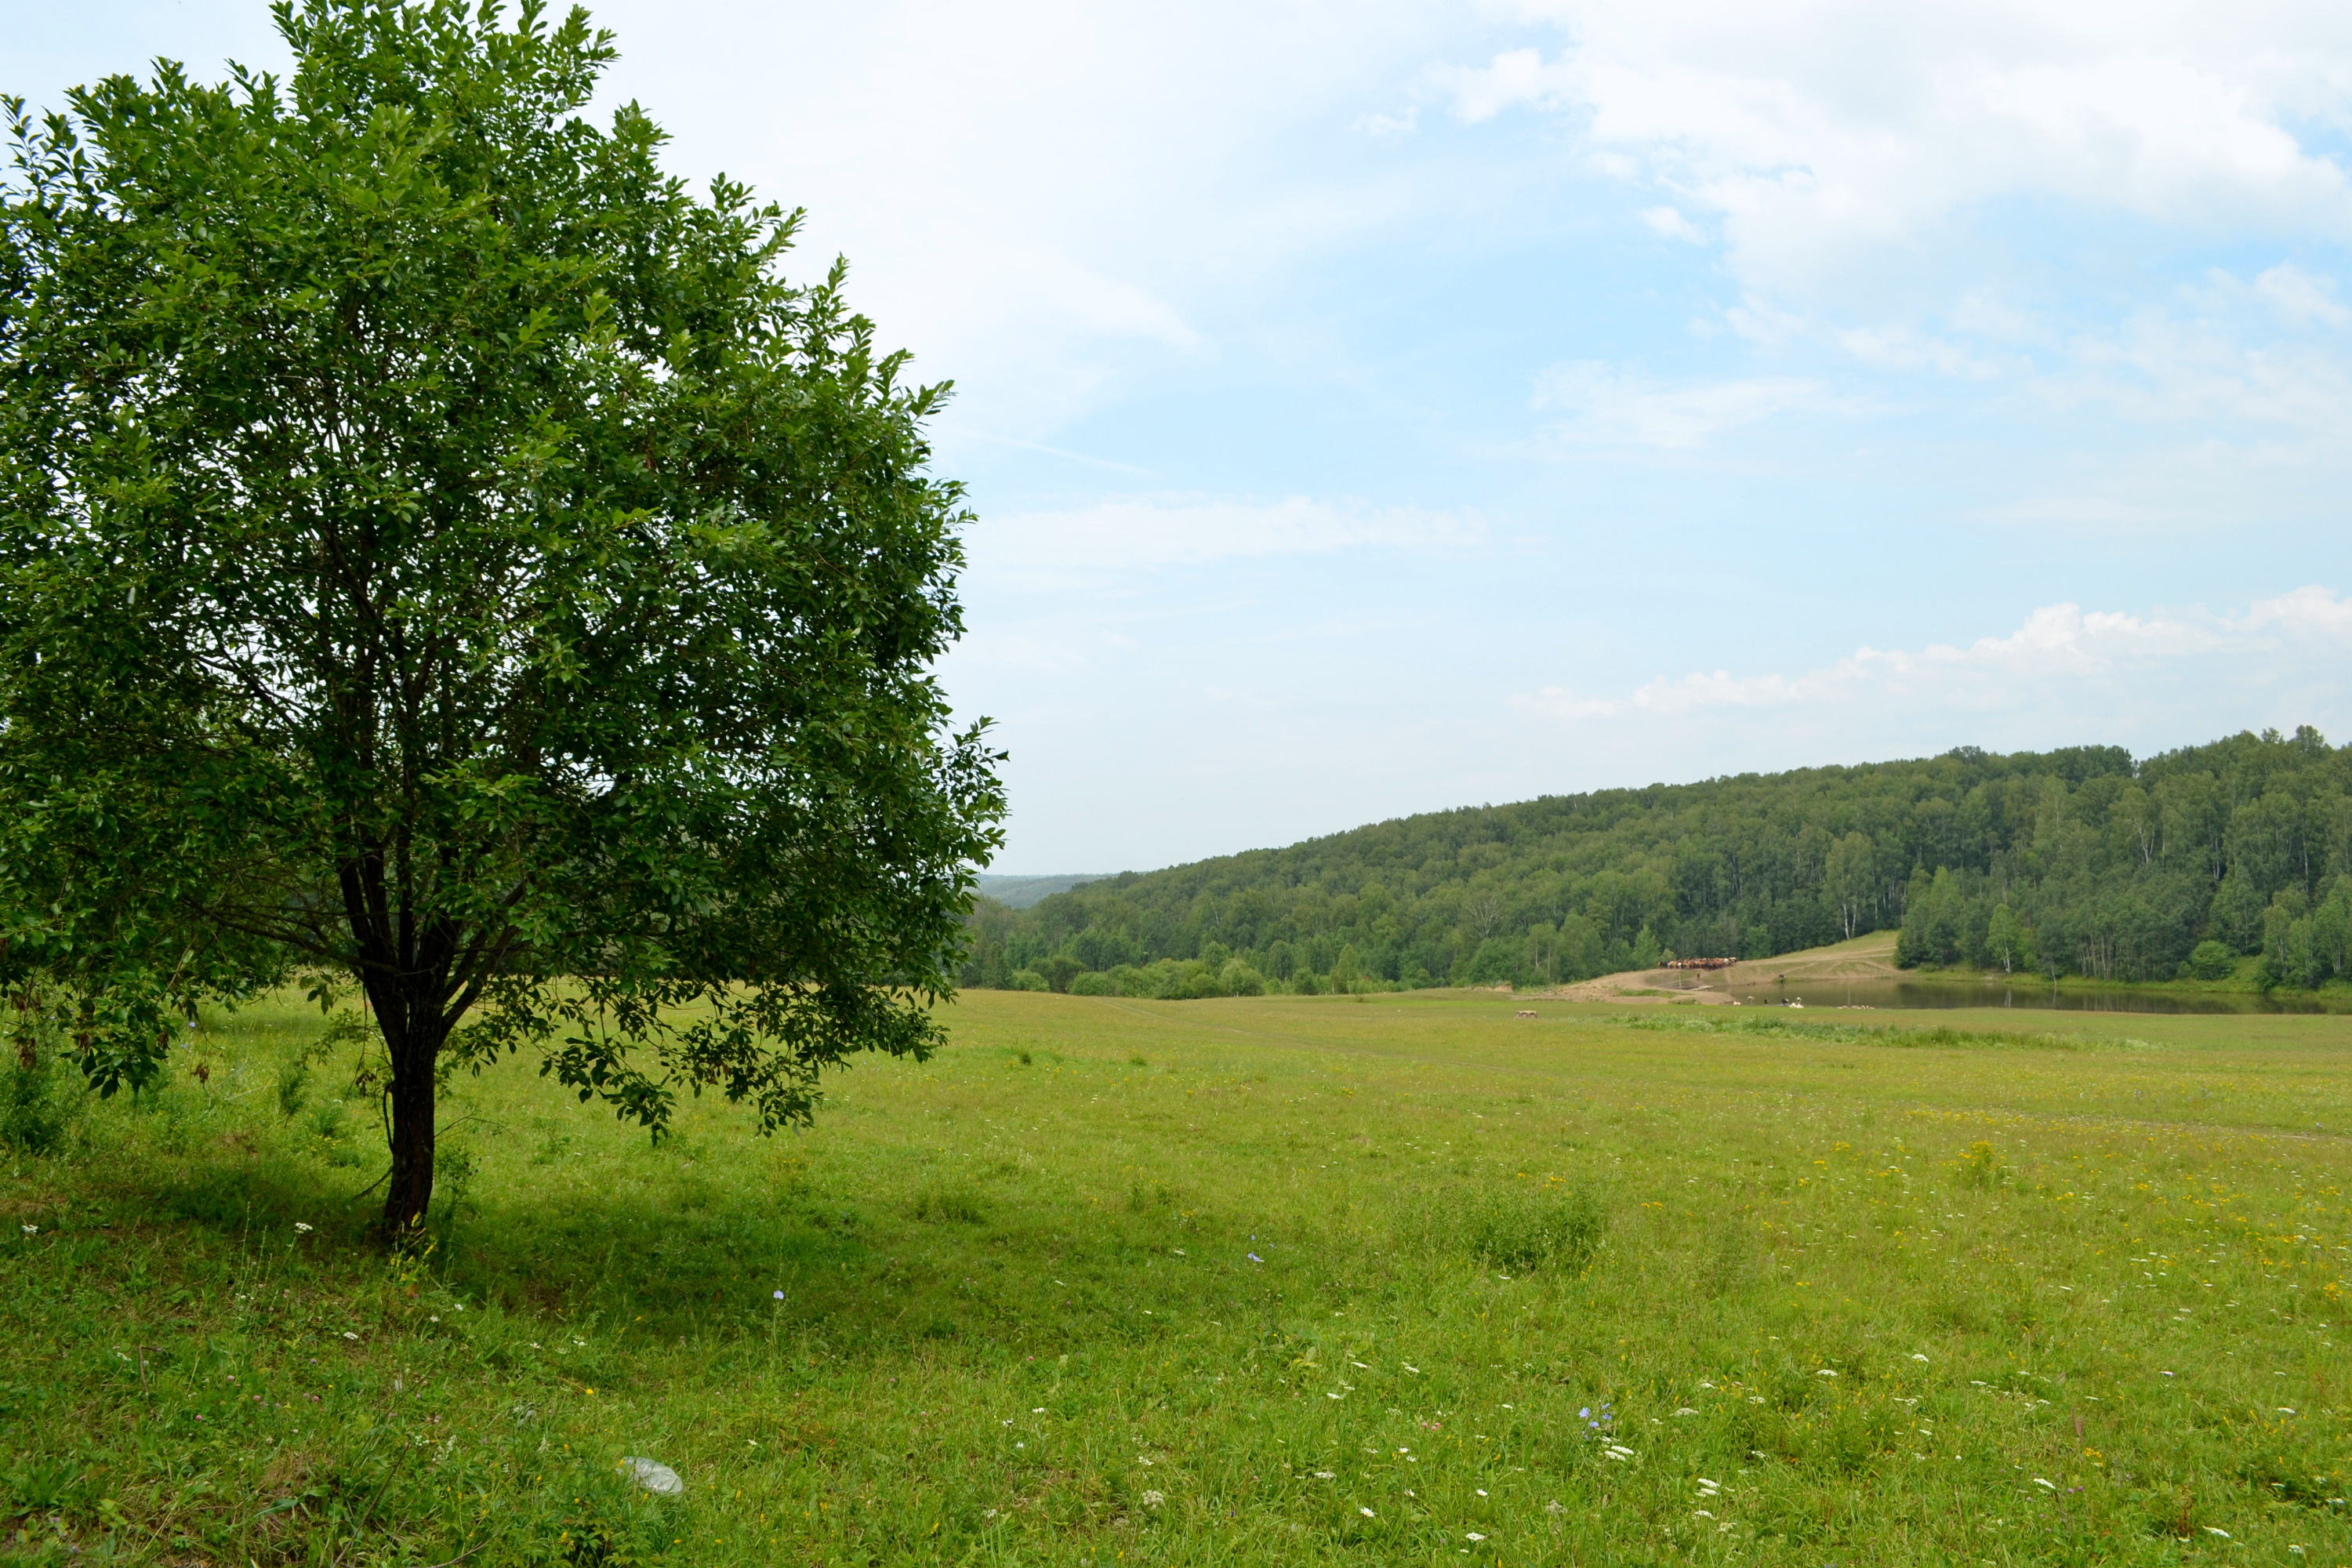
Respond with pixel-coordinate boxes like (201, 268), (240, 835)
(964, 727), (2352, 996)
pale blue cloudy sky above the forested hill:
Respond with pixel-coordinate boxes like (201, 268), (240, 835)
(18, 0), (2352, 872)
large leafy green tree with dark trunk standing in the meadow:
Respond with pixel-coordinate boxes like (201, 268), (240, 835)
(0, 0), (1004, 1232)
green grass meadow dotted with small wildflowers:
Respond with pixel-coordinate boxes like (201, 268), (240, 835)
(0, 992), (2352, 1568)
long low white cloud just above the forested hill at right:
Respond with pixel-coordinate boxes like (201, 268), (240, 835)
(1515, 586), (2352, 720)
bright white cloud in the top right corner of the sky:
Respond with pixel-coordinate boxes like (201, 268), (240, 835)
(1435, 0), (2352, 299)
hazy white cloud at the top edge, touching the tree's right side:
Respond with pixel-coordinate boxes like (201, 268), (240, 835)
(595, 0), (1444, 435)
